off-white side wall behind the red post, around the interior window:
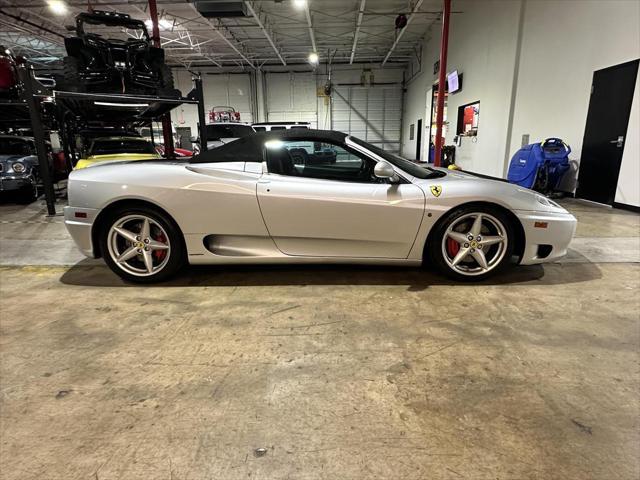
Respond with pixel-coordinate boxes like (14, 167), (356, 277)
(403, 0), (521, 176)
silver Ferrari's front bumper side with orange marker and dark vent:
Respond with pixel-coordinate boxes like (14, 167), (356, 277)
(515, 211), (578, 265)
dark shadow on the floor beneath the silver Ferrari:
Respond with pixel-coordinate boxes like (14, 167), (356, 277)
(60, 253), (602, 291)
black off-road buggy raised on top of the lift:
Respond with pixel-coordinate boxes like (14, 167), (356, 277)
(58, 11), (180, 97)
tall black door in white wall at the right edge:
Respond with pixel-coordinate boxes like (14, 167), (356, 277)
(576, 60), (638, 205)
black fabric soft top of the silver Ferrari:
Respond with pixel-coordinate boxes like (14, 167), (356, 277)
(189, 129), (347, 163)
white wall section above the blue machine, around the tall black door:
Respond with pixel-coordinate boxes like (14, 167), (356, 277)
(508, 0), (640, 191)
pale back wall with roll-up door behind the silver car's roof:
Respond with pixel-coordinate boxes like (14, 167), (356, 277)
(172, 69), (402, 152)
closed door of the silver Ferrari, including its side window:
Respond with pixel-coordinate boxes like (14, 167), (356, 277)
(257, 138), (425, 258)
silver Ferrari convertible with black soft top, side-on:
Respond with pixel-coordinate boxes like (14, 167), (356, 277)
(65, 130), (576, 282)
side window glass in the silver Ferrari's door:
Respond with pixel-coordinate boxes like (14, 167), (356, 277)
(265, 140), (384, 183)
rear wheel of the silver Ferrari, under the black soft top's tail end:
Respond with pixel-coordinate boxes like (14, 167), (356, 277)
(99, 206), (186, 283)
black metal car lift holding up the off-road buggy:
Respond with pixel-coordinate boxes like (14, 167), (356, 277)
(14, 64), (207, 216)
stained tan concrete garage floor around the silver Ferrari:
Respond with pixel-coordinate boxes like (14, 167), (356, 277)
(0, 197), (640, 480)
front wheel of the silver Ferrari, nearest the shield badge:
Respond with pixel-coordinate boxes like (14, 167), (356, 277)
(427, 205), (515, 282)
